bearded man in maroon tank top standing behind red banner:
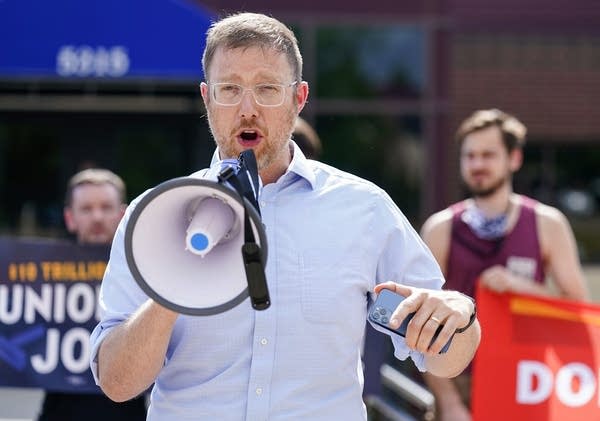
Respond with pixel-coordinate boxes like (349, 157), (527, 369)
(421, 109), (588, 421)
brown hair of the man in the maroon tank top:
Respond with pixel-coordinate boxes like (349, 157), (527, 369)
(455, 108), (527, 152)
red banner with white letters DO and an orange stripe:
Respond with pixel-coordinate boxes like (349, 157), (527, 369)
(472, 288), (600, 421)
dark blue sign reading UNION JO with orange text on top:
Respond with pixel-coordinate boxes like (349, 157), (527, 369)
(0, 237), (110, 393)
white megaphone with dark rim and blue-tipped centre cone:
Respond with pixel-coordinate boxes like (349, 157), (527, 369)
(125, 149), (270, 315)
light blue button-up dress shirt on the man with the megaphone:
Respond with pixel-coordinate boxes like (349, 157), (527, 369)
(90, 142), (443, 421)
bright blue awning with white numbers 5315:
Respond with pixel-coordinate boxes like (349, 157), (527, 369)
(0, 0), (215, 80)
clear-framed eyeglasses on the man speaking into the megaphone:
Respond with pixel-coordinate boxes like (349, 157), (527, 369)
(208, 81), (298, 107)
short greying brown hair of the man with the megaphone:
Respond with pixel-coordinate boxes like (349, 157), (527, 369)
(202, 13), (302, 82)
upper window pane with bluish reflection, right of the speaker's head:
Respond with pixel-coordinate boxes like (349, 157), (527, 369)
(316, 26), (426, 100)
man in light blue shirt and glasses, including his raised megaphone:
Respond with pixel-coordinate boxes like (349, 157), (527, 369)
(91, 13), (480, 421)
